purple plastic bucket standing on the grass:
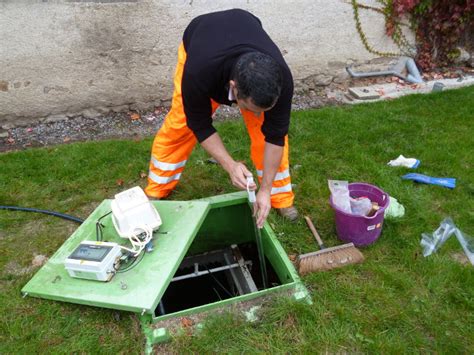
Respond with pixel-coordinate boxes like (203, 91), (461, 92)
(329, 182), (390, 246)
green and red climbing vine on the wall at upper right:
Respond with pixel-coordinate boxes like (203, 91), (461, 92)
(351, 0), (474, 69)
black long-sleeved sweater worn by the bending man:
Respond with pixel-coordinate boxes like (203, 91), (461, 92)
(181, 9), (293, 146)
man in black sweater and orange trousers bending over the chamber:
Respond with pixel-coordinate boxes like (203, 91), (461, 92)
(145, 9), (298, 228)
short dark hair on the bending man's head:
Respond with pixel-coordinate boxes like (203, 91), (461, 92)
(232, 52), (282, 108)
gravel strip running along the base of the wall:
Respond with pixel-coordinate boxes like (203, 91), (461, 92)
(0, 68), (473, 152)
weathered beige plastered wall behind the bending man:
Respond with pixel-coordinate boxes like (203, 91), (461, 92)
(0, 0), (412, 129)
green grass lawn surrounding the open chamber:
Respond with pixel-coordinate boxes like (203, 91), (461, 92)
(0, 87), (474, 354)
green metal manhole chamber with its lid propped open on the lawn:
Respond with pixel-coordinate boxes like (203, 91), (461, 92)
(22, 192), (311, 352)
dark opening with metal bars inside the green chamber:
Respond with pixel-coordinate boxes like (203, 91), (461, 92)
(155, 243), (281, 316)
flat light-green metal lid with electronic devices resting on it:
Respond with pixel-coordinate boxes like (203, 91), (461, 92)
(21, 200), (210, 314)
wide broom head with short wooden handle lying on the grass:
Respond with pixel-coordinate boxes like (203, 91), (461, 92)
(297, 216), (364, 275)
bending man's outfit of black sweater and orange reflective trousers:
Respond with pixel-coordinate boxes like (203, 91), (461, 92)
(145, 9), (294, 208)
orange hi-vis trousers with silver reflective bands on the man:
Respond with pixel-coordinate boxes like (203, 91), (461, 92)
(145, 43), (294, 208)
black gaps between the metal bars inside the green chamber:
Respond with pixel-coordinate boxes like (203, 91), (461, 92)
(155, 243), (281, 316)
